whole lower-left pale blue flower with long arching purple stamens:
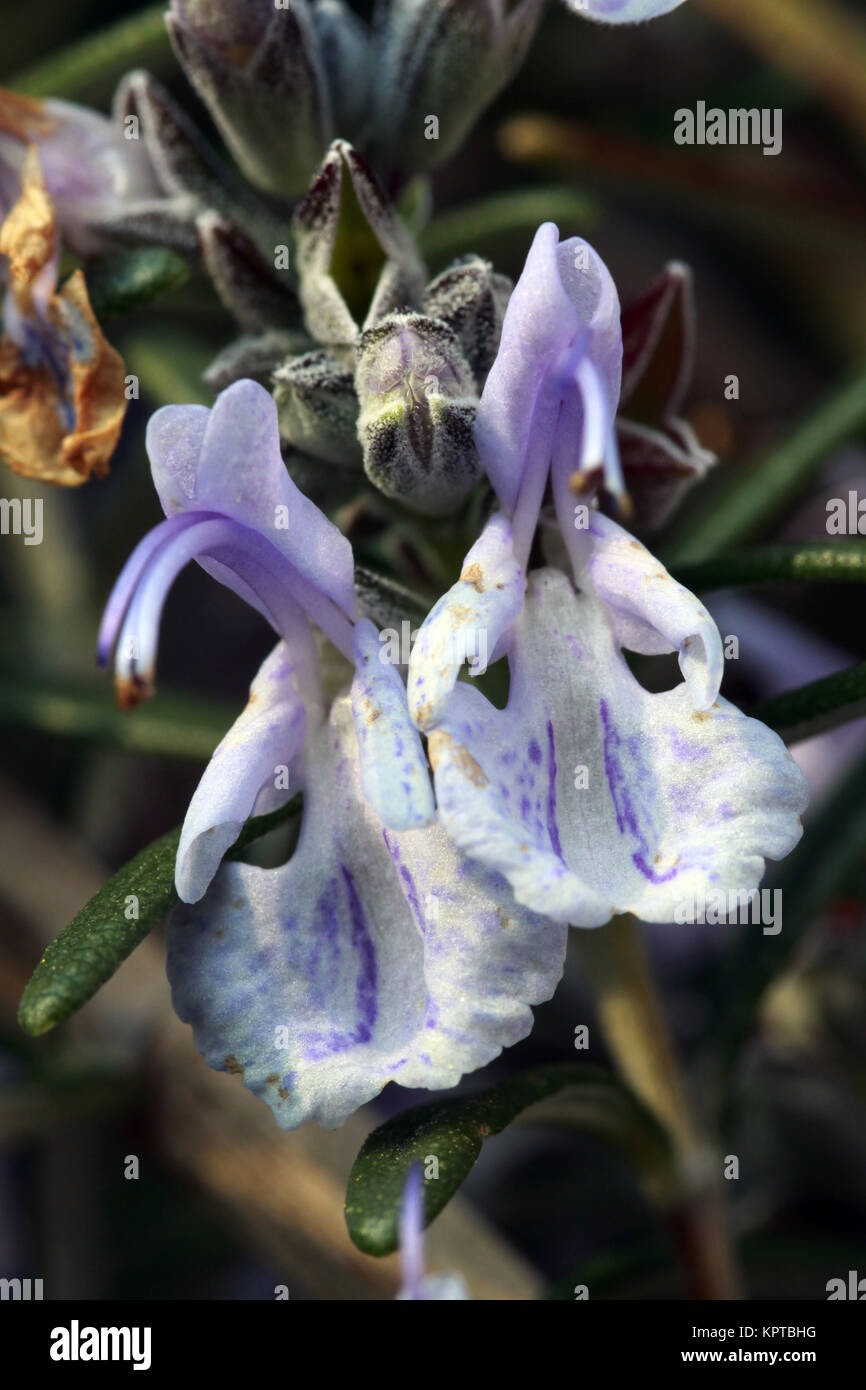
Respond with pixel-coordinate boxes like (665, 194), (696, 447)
(100, 381), (564, 1129)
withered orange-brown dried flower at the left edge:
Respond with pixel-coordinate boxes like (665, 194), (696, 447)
(0, 146), (126, 488)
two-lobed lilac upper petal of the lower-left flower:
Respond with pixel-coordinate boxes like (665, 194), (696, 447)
(147, 381), (356, 617)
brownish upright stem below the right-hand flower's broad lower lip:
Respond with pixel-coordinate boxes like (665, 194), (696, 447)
(577, 916), (740, 1300)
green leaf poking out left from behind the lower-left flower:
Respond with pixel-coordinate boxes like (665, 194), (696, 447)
(18, 796), (300, 1037)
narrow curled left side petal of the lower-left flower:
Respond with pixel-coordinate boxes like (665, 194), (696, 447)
(175, 636), (321, 902)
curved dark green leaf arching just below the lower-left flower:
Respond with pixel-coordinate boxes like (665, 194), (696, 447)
(346, 1063), (671, 1255)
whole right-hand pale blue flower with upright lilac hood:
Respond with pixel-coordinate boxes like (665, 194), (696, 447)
(409, 224), (806, 927)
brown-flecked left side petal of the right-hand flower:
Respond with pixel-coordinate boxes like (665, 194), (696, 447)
(407, 513), (525, 730)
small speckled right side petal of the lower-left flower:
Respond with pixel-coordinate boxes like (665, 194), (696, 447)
(352, 619), (436, 830)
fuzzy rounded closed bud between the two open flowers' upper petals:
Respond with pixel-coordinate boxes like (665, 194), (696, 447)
(354, 314), (481, 516)
